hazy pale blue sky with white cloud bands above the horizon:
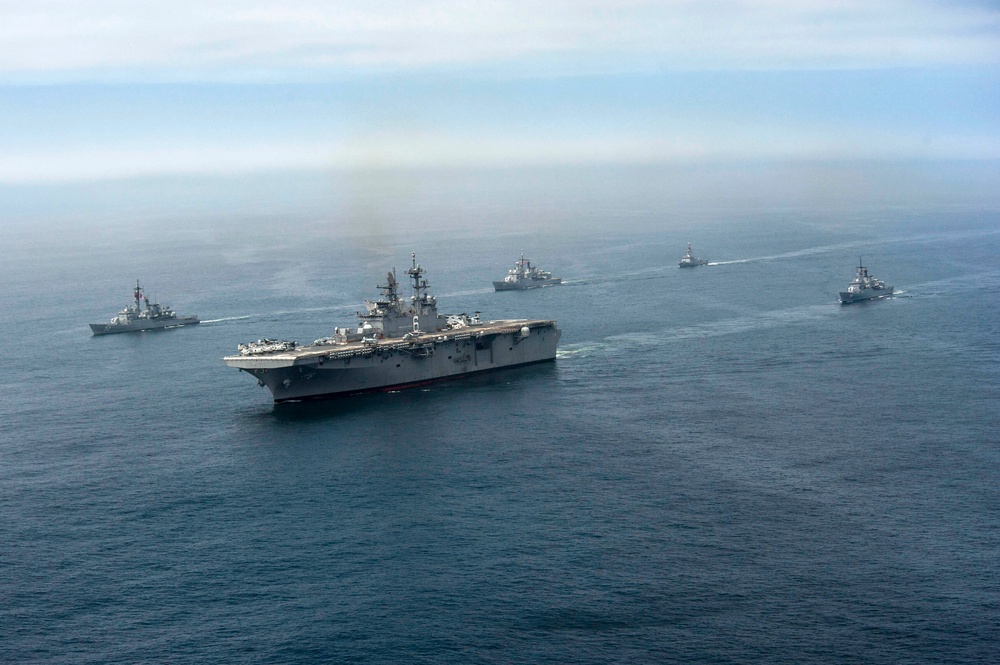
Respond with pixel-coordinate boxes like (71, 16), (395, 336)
(0, 0), (1000, 183)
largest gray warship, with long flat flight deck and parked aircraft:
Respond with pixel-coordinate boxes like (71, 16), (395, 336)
(223, 254), (562, 403)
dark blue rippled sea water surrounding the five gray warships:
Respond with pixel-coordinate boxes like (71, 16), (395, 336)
(0, 200), (1000, 663)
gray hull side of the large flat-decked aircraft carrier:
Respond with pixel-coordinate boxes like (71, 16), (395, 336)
(244, 326), (561, 402)
